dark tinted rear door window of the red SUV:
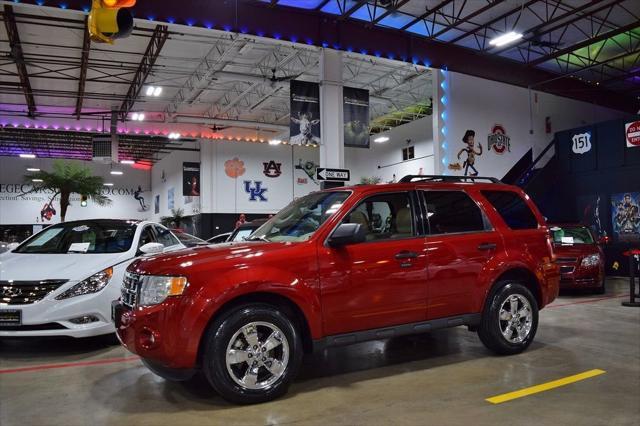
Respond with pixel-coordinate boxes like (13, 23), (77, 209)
(424, 191), (487, 235)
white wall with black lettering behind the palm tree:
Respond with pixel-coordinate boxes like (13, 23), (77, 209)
(0, 157), (151, 225)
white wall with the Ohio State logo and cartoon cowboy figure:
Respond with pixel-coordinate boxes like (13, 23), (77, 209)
(436, 72), (627, 178)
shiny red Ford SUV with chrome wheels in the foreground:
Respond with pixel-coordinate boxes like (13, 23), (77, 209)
(113, 176), (560, 403)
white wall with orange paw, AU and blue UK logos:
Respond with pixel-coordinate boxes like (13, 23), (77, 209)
(150, 140), (320, 219)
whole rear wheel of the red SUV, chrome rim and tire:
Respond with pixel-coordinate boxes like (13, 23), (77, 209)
(478, 281), (538, 355)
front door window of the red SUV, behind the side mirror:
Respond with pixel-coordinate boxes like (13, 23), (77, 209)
(343, 192), (415, 241)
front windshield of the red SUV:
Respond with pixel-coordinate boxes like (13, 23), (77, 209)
(251, 191), (350, 241)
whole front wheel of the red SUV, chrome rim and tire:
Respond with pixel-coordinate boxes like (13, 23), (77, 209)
(202, 303), (303, 404)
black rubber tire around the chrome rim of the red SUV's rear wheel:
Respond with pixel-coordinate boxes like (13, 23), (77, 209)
(478, 281), (538, 355)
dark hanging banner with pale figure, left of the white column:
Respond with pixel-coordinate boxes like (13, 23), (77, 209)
(289, 80), (320, 145)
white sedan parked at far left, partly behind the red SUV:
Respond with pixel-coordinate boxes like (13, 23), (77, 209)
(0, 219), (185, 338)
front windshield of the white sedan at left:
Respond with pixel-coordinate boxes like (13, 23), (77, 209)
(14, 221), (136, 254)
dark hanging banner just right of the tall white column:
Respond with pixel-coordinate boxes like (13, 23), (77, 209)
(342, 87), (369, 148)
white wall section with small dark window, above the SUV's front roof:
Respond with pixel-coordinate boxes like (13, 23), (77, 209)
(345, 117), (435, 184)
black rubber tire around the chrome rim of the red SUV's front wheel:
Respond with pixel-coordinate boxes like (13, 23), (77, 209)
(202, 303), (303, 404)
